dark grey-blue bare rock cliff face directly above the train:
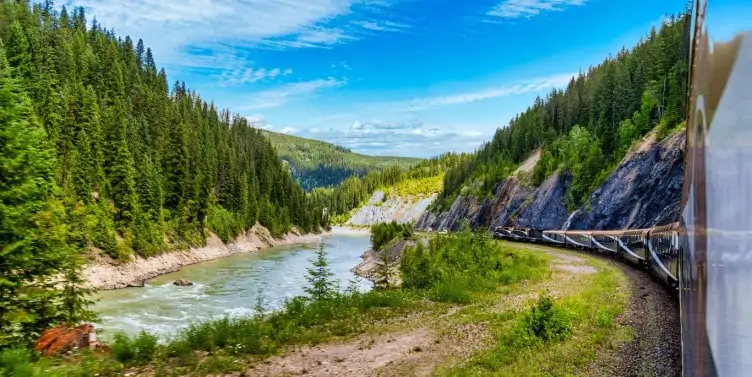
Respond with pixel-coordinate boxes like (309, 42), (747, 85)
(416, 132), (684, 230)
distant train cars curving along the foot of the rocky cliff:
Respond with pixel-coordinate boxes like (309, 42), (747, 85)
(492, 223), (682, 297)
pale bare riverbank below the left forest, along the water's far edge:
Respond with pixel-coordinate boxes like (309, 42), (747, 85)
(82, 224), (330, 290)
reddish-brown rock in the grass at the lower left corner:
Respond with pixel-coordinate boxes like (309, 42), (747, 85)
(34, 323), (100, 356)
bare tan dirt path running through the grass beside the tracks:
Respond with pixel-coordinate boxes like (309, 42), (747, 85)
(230, 245), (597, 377)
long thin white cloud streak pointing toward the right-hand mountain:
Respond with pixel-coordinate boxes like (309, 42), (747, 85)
(400, 73), (574, 112)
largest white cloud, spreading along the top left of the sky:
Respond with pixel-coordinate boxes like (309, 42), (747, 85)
(63, 0), (402, 68)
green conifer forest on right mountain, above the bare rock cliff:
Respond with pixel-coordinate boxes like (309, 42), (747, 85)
(432, 13), (689, 213)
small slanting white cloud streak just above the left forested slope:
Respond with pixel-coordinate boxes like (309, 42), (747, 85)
(238, 77), (347, 110)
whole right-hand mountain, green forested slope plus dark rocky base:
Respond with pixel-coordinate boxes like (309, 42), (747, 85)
(418, 13), (689, 229)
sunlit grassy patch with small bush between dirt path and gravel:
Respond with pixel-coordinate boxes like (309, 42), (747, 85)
(438, 251), (632, 376)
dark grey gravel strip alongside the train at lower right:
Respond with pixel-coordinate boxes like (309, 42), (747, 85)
(587, 261), (681, 377)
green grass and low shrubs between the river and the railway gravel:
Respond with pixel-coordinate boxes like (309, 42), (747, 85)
(0, 235), (631, 377)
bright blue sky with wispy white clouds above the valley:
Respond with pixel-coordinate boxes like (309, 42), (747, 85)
(63, 0), (752, 157)
